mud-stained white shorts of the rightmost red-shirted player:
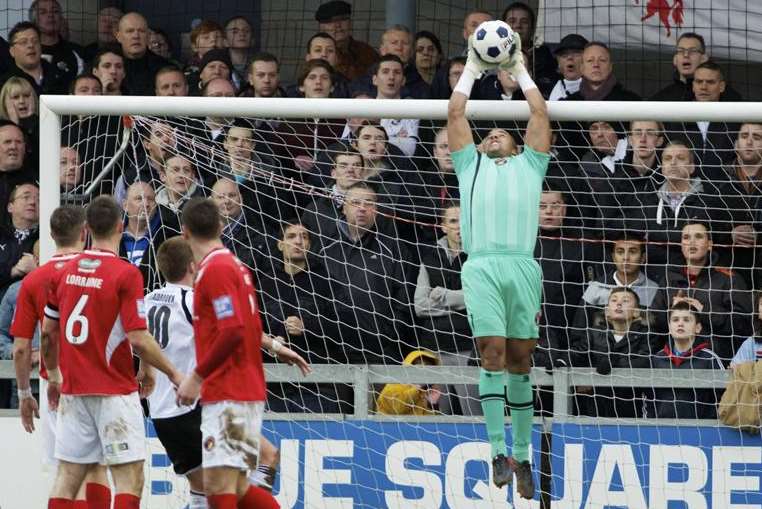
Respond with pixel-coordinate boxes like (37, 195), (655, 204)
(201, 401), (265, 470)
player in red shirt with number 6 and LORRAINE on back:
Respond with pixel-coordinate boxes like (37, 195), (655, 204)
(41, 196), (182, 509)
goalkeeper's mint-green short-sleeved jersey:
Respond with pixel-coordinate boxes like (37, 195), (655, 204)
(452, 143), (550, 258)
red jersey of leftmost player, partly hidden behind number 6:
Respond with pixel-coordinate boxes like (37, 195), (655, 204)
(10, 253), (77, 380)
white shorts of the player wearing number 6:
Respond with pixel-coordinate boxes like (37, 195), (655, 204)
(55, 392), (146, 465)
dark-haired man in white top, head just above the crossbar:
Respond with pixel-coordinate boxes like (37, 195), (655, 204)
(373, 55), (419, 157)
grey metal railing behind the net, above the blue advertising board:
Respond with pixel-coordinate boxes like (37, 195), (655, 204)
(0, 361), (729, 424)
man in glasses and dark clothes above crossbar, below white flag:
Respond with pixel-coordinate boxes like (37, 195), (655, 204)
(651, 32), (741, 101)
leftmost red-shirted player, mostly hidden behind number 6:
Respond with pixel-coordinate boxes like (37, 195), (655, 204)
(10, 205), (111, 509)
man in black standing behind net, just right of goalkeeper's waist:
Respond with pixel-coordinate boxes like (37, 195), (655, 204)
(534, 187), (601, 367)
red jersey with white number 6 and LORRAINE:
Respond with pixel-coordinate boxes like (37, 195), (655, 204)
(45, 249), (146, 395)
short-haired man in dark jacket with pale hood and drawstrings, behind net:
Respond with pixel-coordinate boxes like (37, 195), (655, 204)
(626, 140), (732, 268)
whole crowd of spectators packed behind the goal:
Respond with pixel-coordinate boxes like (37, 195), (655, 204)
(0, 0), (762, 417)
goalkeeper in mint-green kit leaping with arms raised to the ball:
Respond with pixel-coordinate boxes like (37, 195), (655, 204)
(447, 28), (551, 499)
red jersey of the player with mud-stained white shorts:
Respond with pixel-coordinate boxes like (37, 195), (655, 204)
(193, 248), (265, 403)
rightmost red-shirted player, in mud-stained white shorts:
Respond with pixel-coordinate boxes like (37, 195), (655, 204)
(177, 198), (309, 509)
